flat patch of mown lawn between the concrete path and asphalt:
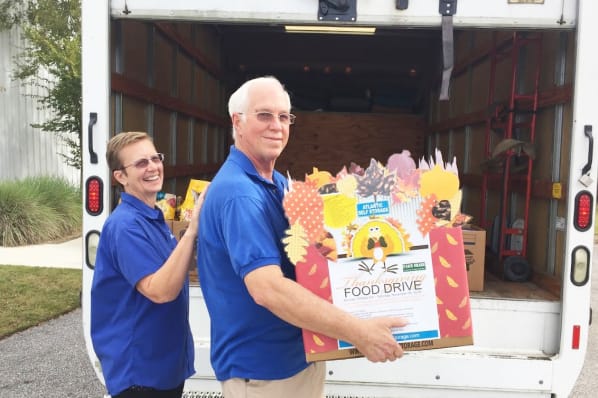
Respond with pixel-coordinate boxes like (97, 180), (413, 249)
(0, 265), (82, 339)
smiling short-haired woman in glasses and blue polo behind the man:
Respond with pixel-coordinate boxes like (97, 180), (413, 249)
(91, 132), (203, 398)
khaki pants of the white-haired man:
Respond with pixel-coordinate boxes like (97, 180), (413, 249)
(222, 362), (326, 398)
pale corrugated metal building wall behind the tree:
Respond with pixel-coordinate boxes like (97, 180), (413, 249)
(0, 28), (80, 184)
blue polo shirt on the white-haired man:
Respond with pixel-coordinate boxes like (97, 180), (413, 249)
(197, 146), (307, 380)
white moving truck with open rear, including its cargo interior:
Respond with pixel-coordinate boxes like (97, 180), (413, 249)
(82, 0), (598, 398)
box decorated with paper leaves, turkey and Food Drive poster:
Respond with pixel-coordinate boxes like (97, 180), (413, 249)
(283, 151), (473, 361)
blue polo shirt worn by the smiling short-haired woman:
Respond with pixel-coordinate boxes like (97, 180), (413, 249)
(91, 193), (195, 395)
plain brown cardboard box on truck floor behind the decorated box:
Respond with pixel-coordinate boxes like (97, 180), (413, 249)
(462, 225), (486, 292)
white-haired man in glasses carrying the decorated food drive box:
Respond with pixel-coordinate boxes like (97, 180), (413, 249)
(198, 77), (405, 398)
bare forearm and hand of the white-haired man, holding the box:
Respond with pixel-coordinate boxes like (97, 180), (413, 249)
(245, 265), (407, 362)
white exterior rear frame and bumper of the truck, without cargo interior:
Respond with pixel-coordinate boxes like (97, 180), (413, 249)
(82, 0), (598, 398)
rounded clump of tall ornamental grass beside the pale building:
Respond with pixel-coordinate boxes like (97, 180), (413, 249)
(0, 177), (82, 246)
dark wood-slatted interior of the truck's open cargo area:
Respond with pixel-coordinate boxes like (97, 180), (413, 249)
(111, 19), (573, 301)
